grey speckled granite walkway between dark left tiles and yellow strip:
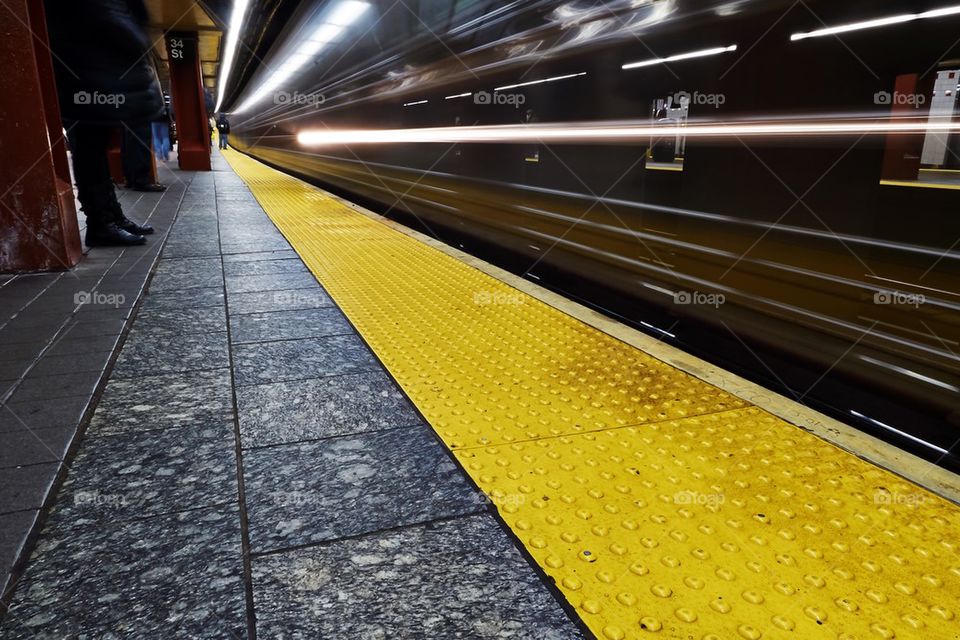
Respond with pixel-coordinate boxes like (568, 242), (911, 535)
(0, 152), (583, 640)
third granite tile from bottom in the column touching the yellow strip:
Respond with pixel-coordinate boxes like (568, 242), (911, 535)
(237, 371), (420, 448)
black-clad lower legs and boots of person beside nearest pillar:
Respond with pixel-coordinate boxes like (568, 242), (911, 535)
(67, 122), (146, 247)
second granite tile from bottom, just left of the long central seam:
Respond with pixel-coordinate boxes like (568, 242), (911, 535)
(50, 422), (237, 527)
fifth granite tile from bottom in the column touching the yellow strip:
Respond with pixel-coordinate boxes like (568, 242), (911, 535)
(230, 306), (354, 344)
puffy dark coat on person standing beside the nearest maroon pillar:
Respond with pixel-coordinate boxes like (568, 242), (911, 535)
(45, 0), (164, 123)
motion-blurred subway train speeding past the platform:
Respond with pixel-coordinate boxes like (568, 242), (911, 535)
(221, 0), (960, 467)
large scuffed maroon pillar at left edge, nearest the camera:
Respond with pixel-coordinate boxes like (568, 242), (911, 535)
(0, 0), (81, 272)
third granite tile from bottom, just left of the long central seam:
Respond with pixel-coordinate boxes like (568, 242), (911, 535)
(87, 368), (233, 437)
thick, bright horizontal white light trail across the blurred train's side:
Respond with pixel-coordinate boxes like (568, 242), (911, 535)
(297, 120), (960, 146)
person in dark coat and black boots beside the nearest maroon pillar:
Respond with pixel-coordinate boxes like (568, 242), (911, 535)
(45, 0), (164, 247)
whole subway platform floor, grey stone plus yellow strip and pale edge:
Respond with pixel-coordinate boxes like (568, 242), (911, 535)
(0, 151), (960, 640)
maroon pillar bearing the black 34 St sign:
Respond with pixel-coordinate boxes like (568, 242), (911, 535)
(167, 33), (210, 171)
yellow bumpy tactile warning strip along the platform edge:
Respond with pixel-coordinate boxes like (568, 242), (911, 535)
(225, 152), (960, 640)
